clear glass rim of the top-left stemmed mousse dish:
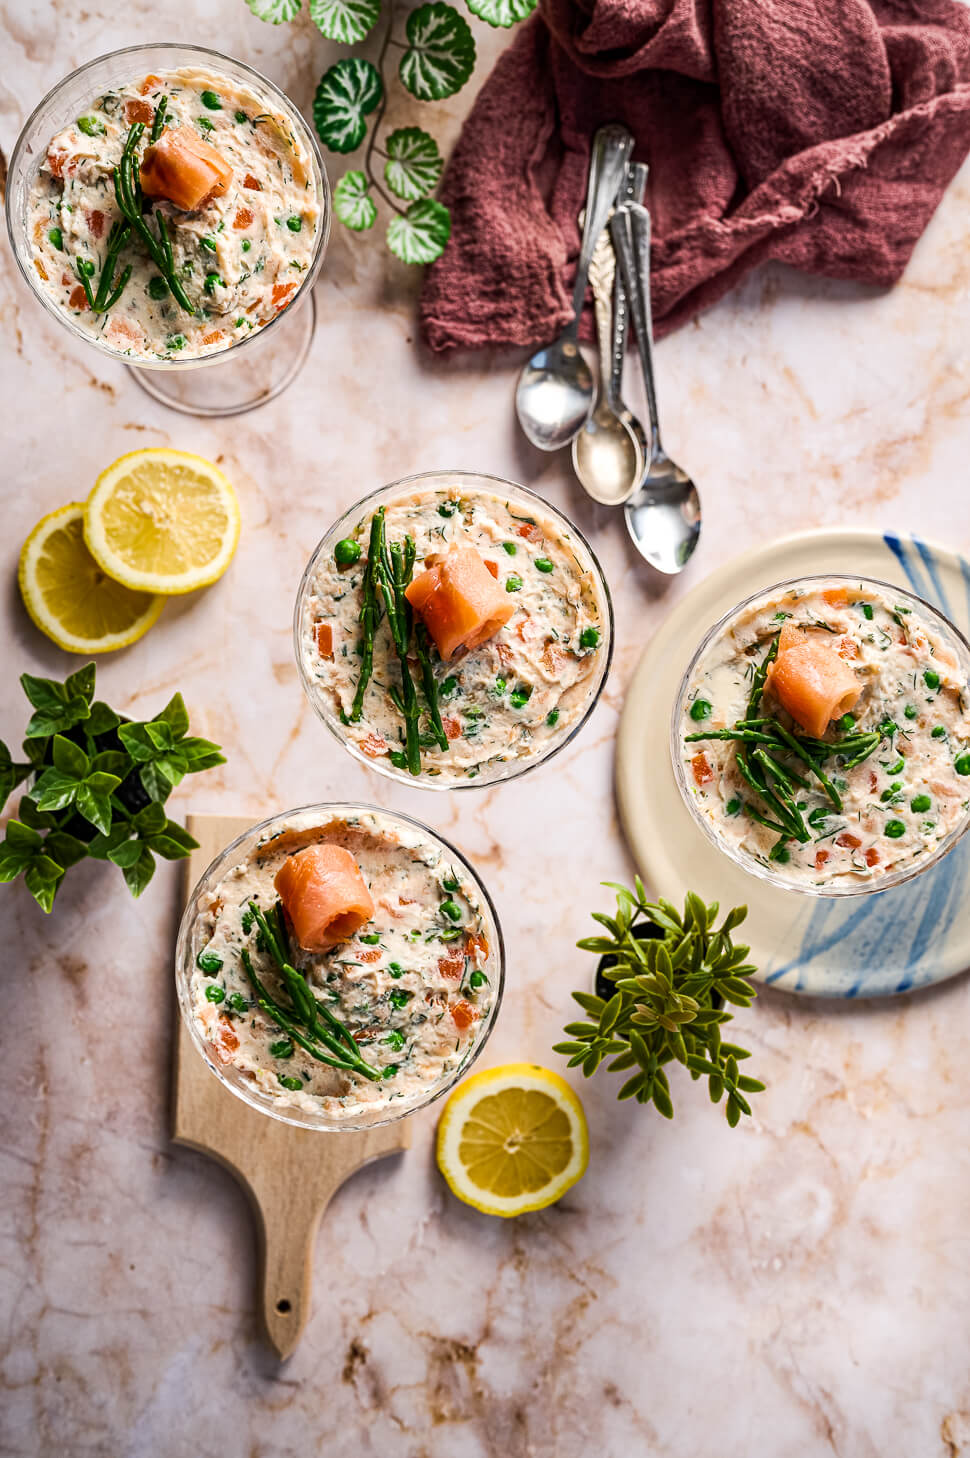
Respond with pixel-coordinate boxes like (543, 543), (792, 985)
(4, 41), (333, 370)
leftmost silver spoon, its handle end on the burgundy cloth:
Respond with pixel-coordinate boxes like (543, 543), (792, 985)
(515, 125), (633, 451)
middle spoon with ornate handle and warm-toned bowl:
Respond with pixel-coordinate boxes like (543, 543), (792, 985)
(572, 162), (651, 506)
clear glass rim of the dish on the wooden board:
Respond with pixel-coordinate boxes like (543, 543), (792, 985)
(175, 800), (506, 1134)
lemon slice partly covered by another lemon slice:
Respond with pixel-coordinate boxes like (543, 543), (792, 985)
(18, 502), (165, 653)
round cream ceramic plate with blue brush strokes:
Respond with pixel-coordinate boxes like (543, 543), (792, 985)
(617, 528), (970, 997)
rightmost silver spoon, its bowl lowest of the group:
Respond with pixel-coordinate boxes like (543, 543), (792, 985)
(610, 203), (700, 576)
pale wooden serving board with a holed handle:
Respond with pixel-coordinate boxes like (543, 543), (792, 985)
(172, 815), (410, 1357)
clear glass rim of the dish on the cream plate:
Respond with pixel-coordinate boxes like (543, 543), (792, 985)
(670, 572), (970, 900)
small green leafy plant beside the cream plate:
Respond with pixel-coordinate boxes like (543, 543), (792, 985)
(554, 876), (764, 1127)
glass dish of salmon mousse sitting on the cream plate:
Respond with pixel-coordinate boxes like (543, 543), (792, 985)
(671, 576), (970, 897)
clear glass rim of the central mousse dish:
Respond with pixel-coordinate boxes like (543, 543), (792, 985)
(293, 469), (616, 795)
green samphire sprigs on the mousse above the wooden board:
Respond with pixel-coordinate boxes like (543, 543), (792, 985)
(241, 901), (384, 1083)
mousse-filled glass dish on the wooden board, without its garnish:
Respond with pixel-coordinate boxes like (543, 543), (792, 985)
(175, 803), (505, 1131)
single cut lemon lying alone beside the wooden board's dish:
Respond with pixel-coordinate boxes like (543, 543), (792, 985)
(438, 1063), (589, 1216)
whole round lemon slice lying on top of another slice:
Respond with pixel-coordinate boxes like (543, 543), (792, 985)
(85, 449), (239, 596)
